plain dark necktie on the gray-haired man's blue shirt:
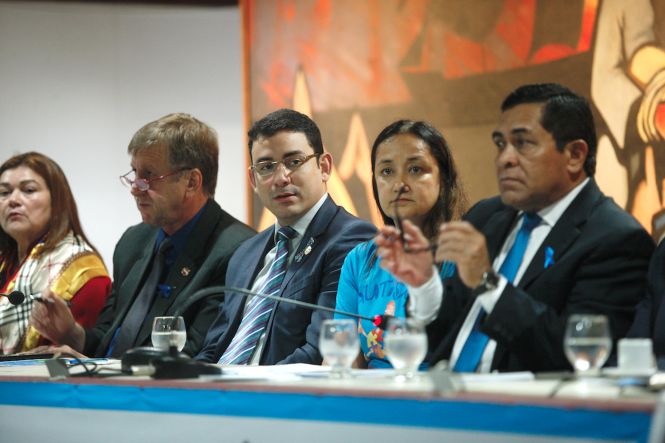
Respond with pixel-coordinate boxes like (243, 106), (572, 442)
(111, 238), (173, 358)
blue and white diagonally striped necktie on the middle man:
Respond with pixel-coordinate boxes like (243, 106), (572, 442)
(218, 226), (296, 365)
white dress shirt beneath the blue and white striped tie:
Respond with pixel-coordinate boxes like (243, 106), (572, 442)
(243, 193), (328, 366)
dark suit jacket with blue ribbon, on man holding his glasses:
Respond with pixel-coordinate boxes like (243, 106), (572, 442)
(433, 180), (654, 371)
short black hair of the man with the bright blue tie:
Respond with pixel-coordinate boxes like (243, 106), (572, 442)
(501, 83), (598, 177)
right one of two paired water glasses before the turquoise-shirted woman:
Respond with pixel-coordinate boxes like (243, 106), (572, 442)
(384, 318), (427, 380)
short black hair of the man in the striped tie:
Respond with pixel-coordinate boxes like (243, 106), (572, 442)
(247, 109), (323, 158)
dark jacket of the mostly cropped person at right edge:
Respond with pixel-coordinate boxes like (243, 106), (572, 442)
(628, 242), (665, 364)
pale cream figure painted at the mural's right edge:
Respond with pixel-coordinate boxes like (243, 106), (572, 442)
(591, 0), (665, 239)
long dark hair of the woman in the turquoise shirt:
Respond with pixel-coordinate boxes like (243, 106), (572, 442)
(371, 120), (466, 238)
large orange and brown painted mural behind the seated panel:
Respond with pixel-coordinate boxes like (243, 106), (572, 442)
(241, 0), (665, 237)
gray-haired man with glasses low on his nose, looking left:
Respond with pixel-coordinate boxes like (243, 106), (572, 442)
(32, 114), (254, 358)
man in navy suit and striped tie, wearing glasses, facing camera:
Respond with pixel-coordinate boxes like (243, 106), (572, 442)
(196, 109), (375, 365)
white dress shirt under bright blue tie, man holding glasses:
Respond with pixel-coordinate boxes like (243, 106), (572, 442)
(409, 178), (589, 372)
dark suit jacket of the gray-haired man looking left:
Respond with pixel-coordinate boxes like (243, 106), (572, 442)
(83, 199), (255, 356)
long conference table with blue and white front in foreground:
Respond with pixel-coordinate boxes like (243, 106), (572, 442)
(0, 361), (661, 443)
